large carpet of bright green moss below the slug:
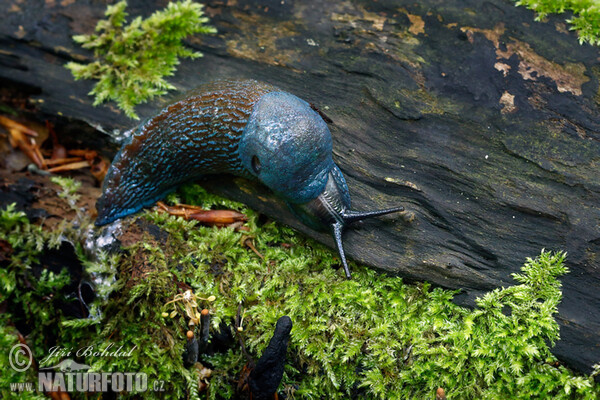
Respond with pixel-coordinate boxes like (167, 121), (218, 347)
(0, 185), (600, 399)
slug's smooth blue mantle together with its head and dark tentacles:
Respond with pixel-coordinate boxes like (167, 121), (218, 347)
(238, 92), (404, 278)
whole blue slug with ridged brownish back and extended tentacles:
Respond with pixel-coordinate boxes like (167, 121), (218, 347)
(96, 80), (403, 278)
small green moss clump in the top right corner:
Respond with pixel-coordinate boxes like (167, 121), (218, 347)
(516, 0), (600, 45)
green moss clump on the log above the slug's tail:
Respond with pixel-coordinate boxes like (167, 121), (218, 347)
(66, 0), (216, 119)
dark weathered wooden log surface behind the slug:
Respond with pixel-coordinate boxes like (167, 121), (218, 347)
(0, 0), (600, 370)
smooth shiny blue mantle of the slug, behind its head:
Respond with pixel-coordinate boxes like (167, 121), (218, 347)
(238, 92), (334, 204)
